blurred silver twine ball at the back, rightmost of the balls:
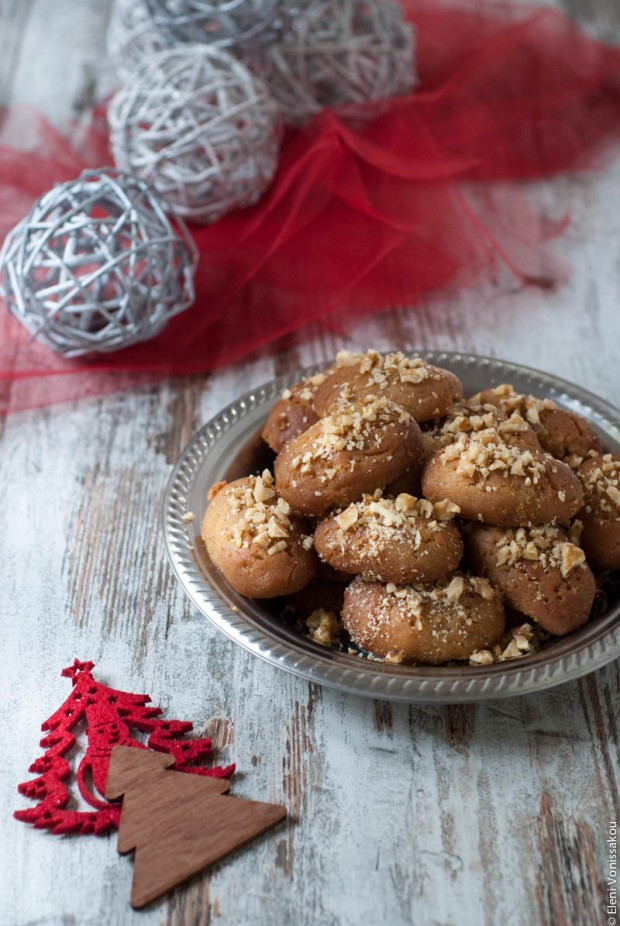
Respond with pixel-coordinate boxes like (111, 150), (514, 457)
(254, 0), (416, 124)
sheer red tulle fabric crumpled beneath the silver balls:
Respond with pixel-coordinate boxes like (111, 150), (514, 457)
(0, 0), (620, 411)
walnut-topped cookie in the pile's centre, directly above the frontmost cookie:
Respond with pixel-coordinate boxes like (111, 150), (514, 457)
(314, 489), (463, 585)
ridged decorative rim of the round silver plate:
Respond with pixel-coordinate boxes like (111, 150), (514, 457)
(162, 351), (620, 703)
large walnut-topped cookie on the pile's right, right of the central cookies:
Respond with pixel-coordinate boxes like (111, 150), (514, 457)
(422, 428), (583, 527)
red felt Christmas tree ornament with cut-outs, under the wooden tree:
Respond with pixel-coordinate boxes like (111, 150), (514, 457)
(15, 659), (235, 835)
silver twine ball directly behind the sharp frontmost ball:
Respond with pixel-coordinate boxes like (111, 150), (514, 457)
(108, 45), (282, 223)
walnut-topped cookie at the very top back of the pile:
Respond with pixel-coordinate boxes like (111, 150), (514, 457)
(314, 350), (463, 421)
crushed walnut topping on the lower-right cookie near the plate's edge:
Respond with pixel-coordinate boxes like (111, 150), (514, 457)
(495, 525), (586, 579)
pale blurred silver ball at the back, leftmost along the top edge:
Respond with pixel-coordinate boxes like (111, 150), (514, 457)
(107, 0), (171, 80)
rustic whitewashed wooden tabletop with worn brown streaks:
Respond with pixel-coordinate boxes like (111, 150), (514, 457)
(0, 0), (620, 926)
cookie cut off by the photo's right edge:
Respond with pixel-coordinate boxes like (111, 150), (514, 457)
(578, 453), (620, 571)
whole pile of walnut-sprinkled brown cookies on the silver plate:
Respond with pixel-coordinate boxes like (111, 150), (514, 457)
(202, 350), (620, 665)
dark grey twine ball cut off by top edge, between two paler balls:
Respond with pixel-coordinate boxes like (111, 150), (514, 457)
(145, 0), (286, 48)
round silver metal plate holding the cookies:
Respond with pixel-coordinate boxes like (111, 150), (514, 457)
(163, 352), (620, 703)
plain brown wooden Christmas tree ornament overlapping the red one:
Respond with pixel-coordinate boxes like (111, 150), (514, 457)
(105, 746), (286, 908)
